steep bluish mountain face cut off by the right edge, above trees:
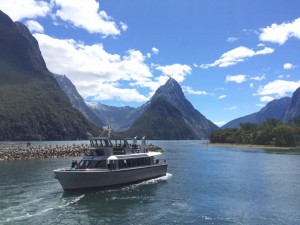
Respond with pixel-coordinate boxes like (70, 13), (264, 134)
(282, 87), (300, 122)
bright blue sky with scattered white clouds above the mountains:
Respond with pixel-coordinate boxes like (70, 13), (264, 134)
(0, 0), (300, 126)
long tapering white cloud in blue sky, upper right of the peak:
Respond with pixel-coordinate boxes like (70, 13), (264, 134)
(200, 46), (274, 69)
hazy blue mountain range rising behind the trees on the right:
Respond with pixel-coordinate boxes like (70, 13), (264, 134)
(222, 87), (300, 129)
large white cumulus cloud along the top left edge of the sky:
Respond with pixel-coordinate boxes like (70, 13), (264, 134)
(0, 0), (123, 37)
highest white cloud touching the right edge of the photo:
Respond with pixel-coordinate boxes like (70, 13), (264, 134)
(259, 18), (300, 45)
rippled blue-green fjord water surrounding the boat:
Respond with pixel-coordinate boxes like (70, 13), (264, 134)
(0, 141), (300, 225)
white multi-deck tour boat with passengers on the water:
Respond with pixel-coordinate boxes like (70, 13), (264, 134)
(53, 127), (168, 191)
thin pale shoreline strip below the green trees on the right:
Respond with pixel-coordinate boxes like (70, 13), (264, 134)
(200, 142), (300, 151)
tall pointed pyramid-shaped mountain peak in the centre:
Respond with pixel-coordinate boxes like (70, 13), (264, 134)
(123, 78), (218, 139)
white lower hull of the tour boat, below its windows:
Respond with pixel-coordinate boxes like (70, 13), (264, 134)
(54, 164), (167, 191)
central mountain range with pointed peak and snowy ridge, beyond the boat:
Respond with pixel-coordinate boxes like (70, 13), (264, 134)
(54, 75), (218, 139)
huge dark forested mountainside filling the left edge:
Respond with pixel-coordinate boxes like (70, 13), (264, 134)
(0, 11), (97, 140)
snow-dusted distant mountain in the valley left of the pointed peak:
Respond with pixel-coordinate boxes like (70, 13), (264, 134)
(87, 102), (144, 132)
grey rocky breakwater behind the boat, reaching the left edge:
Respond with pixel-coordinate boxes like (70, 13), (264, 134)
(0, 144), (163, 161)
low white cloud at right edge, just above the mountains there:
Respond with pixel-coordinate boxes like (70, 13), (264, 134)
(256, 80), (300, 97)
